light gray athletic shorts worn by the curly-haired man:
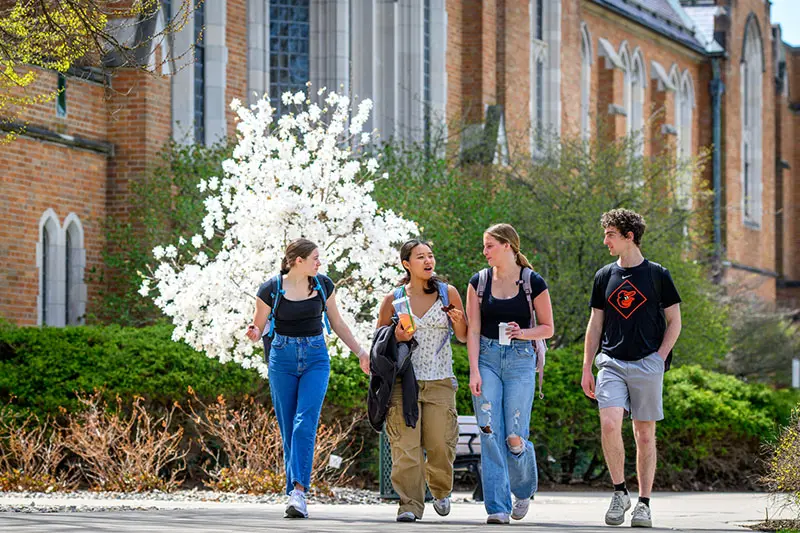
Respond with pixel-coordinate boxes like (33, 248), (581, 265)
(594, 352), (664, 420)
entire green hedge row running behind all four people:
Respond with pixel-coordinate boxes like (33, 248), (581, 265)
(0, 325), (799, 489)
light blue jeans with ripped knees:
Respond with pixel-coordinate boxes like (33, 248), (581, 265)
(472, 337), (539, 514)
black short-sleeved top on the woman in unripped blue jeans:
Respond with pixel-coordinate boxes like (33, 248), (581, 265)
(257, 274), (333, 337)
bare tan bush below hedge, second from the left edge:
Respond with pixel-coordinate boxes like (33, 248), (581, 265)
(64, 392), (188, 492)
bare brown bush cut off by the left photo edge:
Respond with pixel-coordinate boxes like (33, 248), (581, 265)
(0, 406), (77, 492)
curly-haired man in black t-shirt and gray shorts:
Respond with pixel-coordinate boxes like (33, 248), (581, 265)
(581, 209), (681, 527)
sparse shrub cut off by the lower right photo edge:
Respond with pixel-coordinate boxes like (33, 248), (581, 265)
(762, 405), (800, 516)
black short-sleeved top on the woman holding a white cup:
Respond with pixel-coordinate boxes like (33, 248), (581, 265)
(469, 269), (547, 339)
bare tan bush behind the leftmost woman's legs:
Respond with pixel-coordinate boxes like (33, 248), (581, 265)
(187, 388), (361, 494)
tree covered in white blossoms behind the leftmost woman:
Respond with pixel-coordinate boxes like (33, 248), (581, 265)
(139, 89), (417, 377)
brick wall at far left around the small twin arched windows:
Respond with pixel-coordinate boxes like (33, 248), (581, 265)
(0, 69), (108, 325)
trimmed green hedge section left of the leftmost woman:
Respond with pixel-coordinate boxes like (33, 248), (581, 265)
(0, 325), (267, 417)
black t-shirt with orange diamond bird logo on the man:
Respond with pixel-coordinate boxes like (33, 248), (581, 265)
(590, 259), (681, 361)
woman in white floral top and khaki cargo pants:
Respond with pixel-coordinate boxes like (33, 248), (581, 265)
(378, 239), (467, 522)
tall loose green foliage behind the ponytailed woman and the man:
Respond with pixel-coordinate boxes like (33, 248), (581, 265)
(376, 132), (728, 367)
